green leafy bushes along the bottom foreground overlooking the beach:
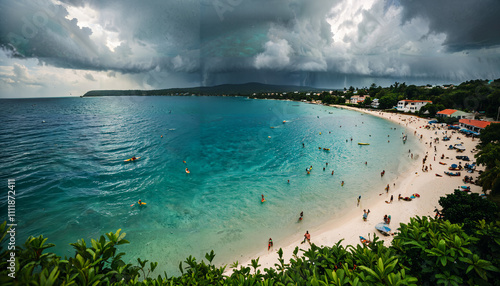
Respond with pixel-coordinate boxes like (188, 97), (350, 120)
(0, 217), (500, 286)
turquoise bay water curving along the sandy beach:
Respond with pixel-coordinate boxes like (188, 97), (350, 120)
(0, 97), (417, 275)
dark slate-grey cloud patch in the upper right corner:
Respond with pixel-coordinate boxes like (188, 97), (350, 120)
(400, 0), (500, 52)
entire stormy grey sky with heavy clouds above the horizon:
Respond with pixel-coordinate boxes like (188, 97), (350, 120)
(0, 0), (500, 97)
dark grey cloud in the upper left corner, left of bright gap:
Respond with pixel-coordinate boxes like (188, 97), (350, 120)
(0, 1), (158, 72)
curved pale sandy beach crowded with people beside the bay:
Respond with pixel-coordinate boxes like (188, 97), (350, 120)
(226, 106), (481, 274)
